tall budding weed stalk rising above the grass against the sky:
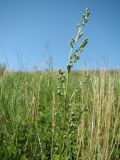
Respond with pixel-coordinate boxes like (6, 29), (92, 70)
(58, 8), (90, 100)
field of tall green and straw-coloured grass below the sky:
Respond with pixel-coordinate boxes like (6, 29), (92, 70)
(0, 70), (120, 160)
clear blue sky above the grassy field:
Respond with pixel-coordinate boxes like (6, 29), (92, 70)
(0, 0), (120, 70)
